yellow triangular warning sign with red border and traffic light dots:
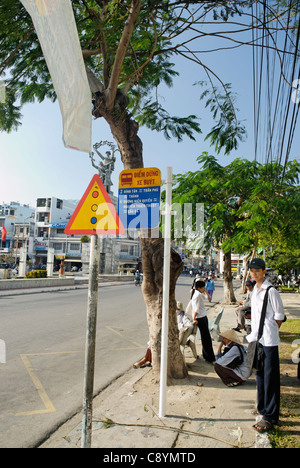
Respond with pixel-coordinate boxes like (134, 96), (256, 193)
(65, 175), (125, 235)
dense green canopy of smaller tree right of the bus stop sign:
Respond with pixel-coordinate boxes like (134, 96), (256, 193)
(173, 153), (300, 253)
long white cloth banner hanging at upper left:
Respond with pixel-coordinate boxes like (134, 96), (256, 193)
(20, 0), (92, 153)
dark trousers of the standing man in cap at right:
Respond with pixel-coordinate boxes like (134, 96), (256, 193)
(256, 346), (280, 424)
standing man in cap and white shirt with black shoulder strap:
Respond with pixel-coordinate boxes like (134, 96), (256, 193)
(247, 258), (284, 432)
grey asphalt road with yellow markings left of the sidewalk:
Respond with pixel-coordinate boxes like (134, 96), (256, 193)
(0, 276), (223, 447)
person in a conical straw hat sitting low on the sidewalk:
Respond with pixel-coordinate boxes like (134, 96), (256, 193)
(215, 330), (251, 387)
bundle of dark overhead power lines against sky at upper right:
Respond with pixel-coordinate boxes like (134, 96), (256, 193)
(252, 0), (300, 178)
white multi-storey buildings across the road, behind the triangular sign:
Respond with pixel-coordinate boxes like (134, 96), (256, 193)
(0, 194), (141, 275)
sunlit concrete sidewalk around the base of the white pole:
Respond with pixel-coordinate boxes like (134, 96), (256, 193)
(41, 294), (300, 452)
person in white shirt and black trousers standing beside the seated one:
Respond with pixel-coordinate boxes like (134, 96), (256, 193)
(186, 281), (216, 363)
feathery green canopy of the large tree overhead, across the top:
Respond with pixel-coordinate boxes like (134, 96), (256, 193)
(0, 0), (296, 157)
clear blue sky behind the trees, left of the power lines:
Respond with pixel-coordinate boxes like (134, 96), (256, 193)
(0, 23), (300, 205)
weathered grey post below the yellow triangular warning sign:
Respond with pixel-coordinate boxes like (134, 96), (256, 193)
(81, 234), (100, 448)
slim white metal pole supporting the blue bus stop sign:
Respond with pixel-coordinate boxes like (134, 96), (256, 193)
(159, 167), (172, 418)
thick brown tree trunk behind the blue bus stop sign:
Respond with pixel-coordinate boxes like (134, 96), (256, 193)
(93, 90), (187, 379)
